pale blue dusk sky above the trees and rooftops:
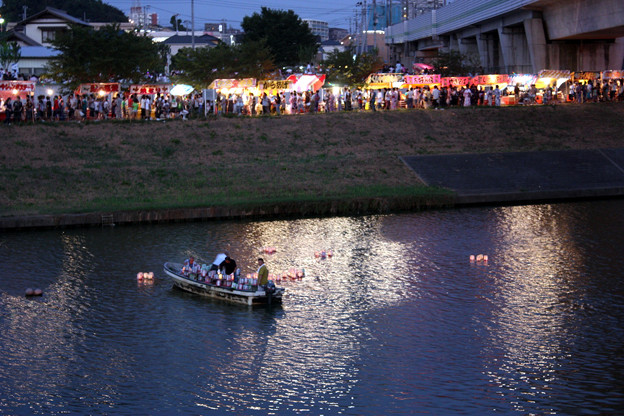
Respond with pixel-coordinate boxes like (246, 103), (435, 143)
(103, 0), (357, 30)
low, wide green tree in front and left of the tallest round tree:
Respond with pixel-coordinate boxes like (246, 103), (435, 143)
(171, 41), (275, 88)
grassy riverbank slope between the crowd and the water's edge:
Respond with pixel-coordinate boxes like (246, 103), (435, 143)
(0, 103), (624, 216)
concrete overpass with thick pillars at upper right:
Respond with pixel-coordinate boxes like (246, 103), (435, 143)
(386, 0), (624, 73)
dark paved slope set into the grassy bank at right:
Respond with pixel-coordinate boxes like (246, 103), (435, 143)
(402, 149), (624, 205)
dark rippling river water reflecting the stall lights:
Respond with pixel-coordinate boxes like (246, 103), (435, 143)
(0, 200), (624, 415)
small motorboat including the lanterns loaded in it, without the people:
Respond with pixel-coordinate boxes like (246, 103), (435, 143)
(163, 262), (286, 306)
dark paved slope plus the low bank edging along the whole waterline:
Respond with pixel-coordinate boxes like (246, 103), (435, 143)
(0, 149), (624, 230)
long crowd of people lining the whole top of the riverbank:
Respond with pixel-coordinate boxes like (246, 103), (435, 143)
(0, 80), (624, 124)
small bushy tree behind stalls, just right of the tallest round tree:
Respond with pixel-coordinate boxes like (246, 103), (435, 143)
(324, 47), (383, 85)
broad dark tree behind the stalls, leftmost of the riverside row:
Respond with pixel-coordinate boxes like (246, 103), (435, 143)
(46, 24), (168, 89)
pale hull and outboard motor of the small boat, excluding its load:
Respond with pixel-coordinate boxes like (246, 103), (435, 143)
(164, 262), (286, 305)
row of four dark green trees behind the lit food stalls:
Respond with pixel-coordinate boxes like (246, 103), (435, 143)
(36, 7), (381, 89)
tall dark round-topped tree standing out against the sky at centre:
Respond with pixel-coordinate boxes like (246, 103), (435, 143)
(241, 7), (318, 67)
